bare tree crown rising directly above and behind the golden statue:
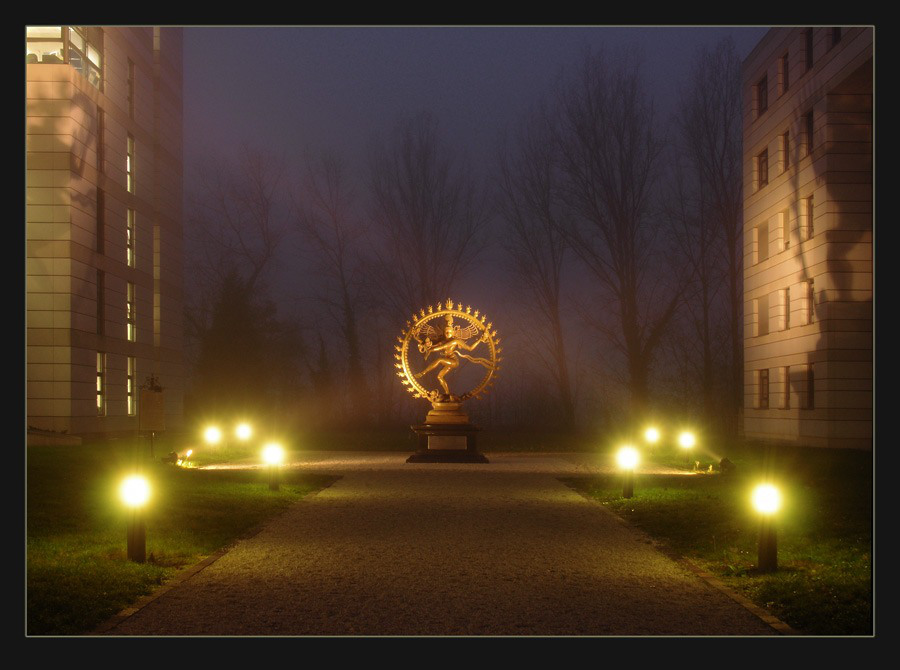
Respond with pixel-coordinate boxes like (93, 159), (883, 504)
(369, 113), (490, 316)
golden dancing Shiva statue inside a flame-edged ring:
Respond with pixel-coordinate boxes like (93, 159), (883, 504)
(394, 300), (502, 408)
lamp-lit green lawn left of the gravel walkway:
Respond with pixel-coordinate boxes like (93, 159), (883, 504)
(26, 441), (336, 635)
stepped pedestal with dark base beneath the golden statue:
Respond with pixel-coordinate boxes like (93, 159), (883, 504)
(406, 402), (490, 463)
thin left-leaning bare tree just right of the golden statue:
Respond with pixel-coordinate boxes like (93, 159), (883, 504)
(498, 105), (575, 430)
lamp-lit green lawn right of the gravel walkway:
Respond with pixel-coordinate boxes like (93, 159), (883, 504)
(564, 447), (873, 635)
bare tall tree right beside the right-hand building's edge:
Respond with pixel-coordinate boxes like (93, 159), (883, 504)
(679, 39), (743, 430)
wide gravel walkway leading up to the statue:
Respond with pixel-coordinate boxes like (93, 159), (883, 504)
(106, 453), (778, 636)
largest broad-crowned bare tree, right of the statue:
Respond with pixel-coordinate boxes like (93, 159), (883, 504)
(557, 48), (683, 420)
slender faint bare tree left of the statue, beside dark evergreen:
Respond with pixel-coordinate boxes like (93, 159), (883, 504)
(295, 155), (371, 420)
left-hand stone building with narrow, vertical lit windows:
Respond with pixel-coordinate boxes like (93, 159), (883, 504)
(25, 26), (184, 442)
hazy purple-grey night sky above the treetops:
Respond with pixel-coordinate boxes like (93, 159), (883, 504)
(184, 27), (767, 312)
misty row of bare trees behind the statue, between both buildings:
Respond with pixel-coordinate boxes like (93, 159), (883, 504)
(185, 41), (743, 444)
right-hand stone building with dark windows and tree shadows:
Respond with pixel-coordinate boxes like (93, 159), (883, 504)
(743, 27), (874, 449)
